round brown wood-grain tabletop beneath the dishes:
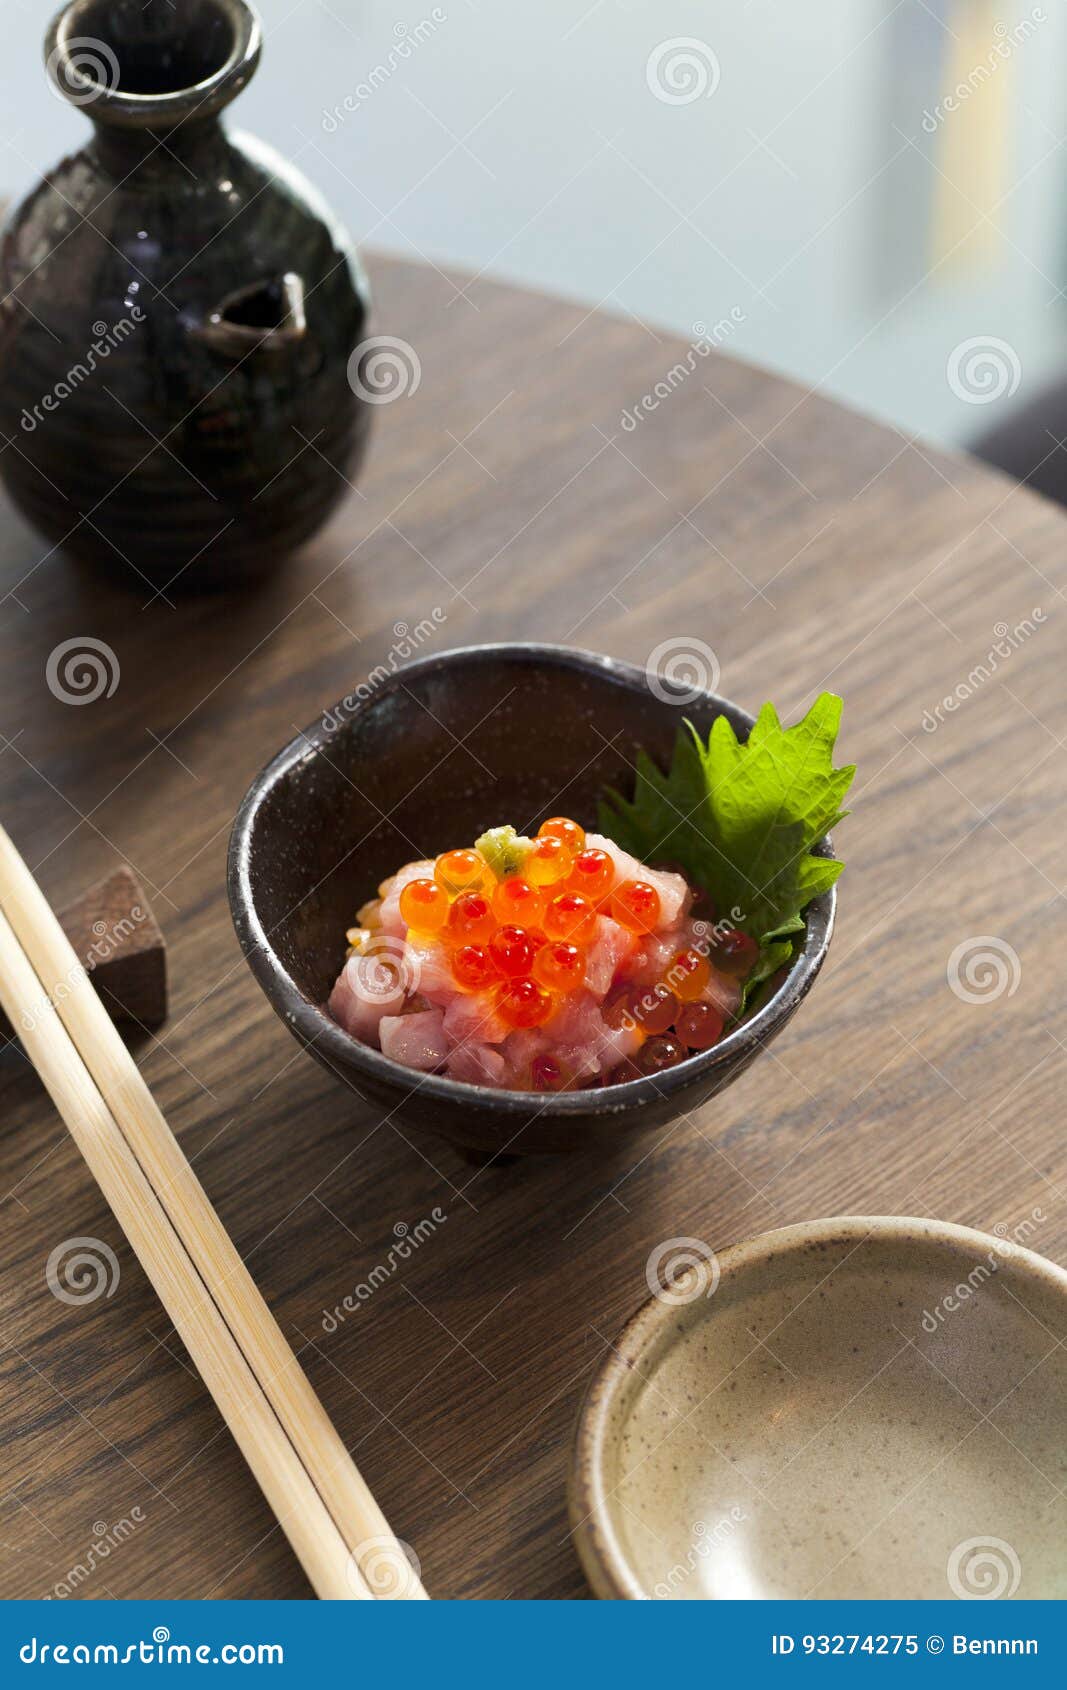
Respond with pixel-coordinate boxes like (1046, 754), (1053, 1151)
(0, 260), (1067, 1597)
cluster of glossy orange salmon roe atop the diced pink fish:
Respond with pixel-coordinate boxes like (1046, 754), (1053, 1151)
(401, 816), (659, 1028)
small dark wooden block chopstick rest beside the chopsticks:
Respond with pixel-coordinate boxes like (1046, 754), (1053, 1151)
(0, 865), (167, 1043)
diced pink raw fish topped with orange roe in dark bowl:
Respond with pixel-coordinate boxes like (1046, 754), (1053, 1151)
(330, 816), (759, 1092)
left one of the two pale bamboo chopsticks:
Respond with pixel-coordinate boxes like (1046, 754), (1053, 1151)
(0, 913), (370, 1600)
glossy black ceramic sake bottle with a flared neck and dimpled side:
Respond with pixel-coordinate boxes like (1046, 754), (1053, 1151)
(0, 0), (370, 595)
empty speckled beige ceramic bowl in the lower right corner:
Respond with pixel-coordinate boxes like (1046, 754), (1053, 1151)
(570, 1217), (1067, 1599)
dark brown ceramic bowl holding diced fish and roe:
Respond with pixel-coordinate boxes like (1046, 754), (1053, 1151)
(228, 646), (835, 1153)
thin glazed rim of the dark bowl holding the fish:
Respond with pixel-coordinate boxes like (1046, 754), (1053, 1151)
(227, 641), (837, 1117)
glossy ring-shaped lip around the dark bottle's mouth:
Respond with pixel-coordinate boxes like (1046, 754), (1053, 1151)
(44, 0), (264, 128)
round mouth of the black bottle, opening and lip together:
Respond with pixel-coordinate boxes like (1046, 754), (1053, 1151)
(44, 0), (262, 128)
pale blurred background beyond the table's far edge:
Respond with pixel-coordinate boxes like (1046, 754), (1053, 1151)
(8, 0), (1067, 443)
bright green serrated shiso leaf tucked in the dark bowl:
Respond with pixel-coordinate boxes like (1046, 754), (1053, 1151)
(599, 693), (856, 1002)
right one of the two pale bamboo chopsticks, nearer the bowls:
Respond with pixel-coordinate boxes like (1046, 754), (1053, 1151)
(0, 826), (426, 1599)
